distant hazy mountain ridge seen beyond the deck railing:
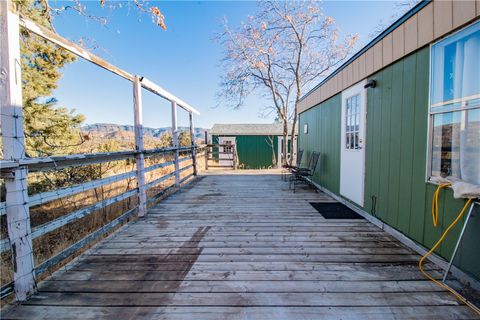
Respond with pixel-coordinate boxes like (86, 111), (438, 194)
(82, 123), (210, 139)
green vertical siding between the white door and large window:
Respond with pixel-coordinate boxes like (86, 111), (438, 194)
(364, 47), (476, 268)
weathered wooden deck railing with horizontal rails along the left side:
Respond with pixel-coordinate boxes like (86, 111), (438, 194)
(0, 146), (204, 298)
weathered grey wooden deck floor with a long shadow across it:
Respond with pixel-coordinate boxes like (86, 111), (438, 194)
(2, 171), (476, 320)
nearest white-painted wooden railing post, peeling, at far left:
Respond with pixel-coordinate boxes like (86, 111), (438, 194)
(0, 1), (35, 301)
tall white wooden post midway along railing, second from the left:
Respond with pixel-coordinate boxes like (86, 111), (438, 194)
(133, 76), (147, 217)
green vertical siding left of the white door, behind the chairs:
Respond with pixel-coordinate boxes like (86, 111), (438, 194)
(298, 95), (341, 194)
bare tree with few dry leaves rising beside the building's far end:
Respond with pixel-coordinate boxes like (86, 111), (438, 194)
(218, 1), (357, 164)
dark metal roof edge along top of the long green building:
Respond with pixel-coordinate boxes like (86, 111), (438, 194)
(298, 0), (433, 102)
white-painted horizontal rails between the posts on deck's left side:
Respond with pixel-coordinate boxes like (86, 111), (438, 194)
(0, 146), (204, 297)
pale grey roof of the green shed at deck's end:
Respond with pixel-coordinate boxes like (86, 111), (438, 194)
(210, 123), (292, 136)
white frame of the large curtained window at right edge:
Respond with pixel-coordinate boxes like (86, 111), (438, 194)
(425, 20), (480, 185)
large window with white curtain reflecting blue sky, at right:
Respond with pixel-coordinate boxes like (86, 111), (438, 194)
(429, 22), (480, 185)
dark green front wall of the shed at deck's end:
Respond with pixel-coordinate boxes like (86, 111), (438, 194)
(212, 135), (278, 169)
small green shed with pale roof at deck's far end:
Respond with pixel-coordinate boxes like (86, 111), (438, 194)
(211, 123), (296, 169)
